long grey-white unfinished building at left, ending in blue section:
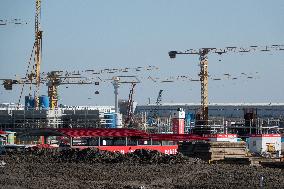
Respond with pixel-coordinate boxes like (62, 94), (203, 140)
(0, 103), (117, 130)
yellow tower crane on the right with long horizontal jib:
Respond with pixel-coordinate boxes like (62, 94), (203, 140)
(168, 45), (284, 125)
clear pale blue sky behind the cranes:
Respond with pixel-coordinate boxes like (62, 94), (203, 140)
(0, 0), (284, 105)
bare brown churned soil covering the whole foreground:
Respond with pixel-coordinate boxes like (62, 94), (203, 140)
(0, 150), (284, 189)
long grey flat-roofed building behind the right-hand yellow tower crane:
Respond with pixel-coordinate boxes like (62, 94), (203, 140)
(136, 103), (284, 136)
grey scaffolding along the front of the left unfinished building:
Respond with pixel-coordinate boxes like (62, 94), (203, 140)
(0, 109), (100, 130)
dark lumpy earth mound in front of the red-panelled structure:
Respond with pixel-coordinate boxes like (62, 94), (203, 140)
(4, 148), (202, 164)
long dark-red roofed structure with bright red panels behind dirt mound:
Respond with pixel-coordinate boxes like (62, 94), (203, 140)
(27, 128), (208, 154)
